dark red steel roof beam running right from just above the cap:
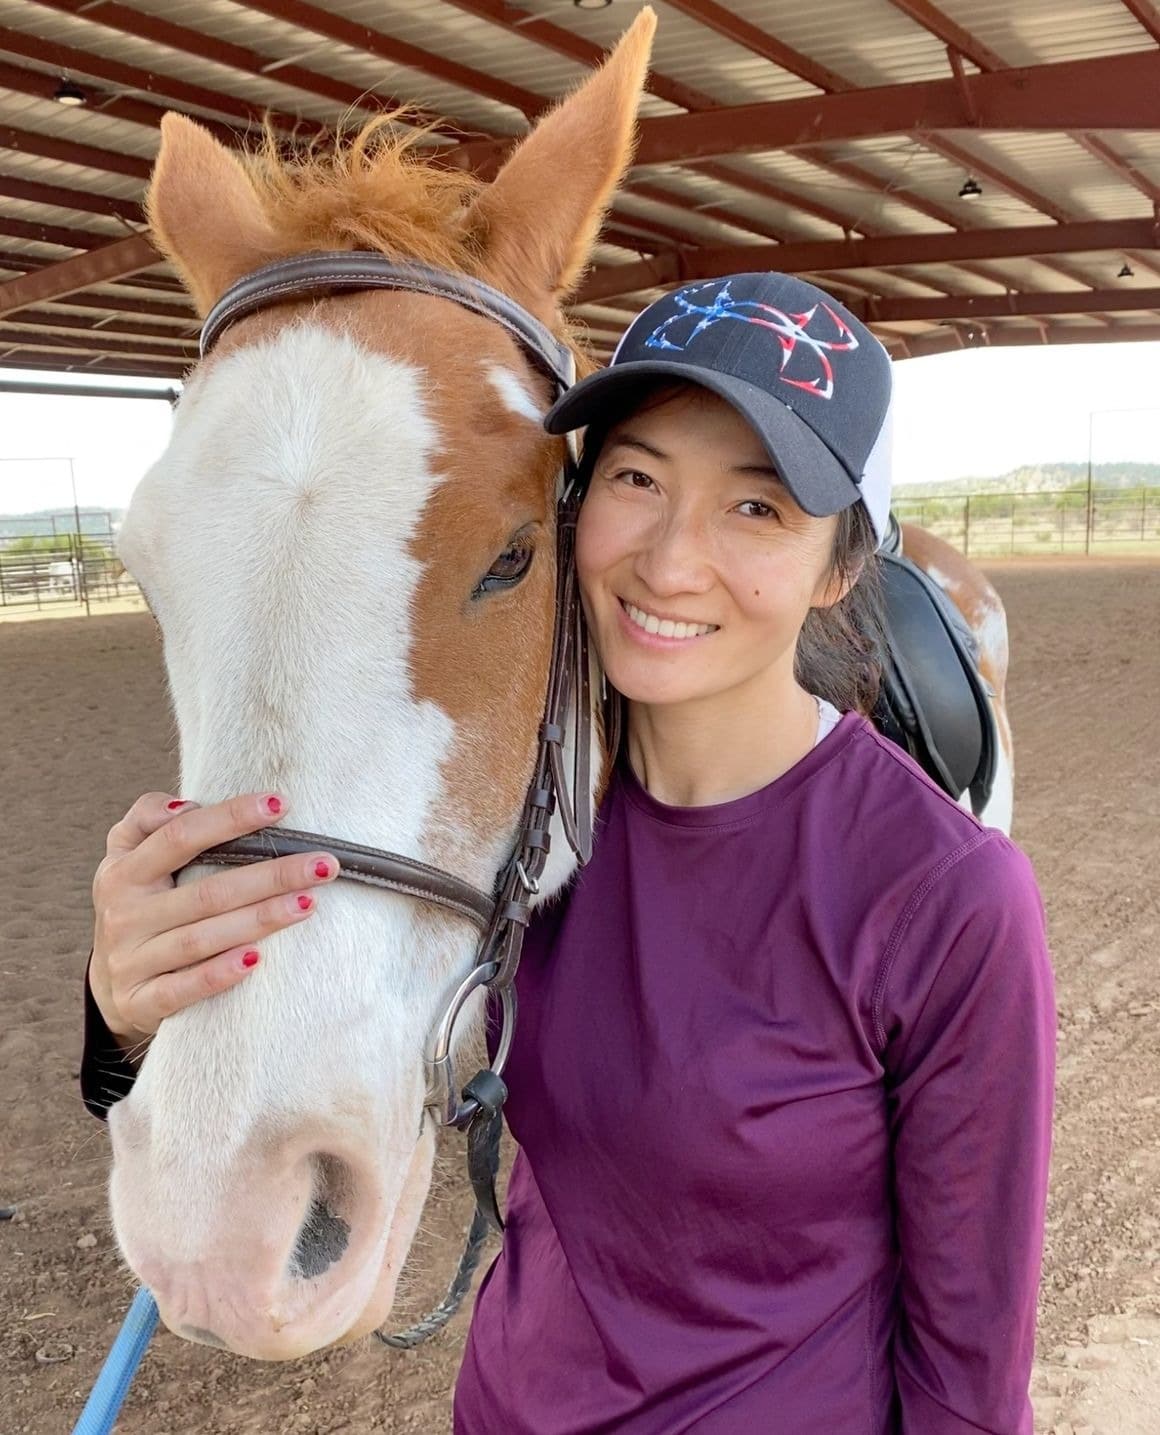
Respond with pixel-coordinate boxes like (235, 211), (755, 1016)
(574, 220), (1160, 304)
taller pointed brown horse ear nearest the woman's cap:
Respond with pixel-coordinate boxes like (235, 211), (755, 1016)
(475, 7), (656, 319)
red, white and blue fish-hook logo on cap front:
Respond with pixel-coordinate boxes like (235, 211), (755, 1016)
(645, 281), (859, 399)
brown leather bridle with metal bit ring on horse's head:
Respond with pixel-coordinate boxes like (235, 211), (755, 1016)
(185, 251), (593, 1347)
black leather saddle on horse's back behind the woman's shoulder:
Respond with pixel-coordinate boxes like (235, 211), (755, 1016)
(871, 514), (998, 817)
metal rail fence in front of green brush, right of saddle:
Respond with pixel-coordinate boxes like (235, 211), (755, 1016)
(894, 486), (1160, 557)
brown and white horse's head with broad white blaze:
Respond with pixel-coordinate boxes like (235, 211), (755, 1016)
(109, 13), (653, 1359)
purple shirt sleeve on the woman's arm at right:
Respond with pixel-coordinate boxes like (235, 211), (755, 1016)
(876, 831), (1055, 1435)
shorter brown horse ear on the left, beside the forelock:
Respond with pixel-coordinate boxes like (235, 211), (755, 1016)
(146, 113), (274, 314)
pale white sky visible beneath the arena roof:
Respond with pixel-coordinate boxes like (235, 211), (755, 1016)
(0, 343), (1160, 514)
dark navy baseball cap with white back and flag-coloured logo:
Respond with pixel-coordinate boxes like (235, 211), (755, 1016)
(544, 273), (893, 542)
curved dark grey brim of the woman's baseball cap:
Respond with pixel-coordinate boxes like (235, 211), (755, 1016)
(544, 359), (861, 518)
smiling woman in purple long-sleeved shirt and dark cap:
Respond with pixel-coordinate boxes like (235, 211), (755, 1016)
(86, 274), (1054, 1435)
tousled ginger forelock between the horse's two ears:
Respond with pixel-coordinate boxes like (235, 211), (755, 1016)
(245, 110), (485, 276)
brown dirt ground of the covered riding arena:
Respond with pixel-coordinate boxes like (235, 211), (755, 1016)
(0, 560), (1160, 1435)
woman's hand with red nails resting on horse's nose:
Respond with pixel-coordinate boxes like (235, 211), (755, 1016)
(89, 792), (339, 1049)
